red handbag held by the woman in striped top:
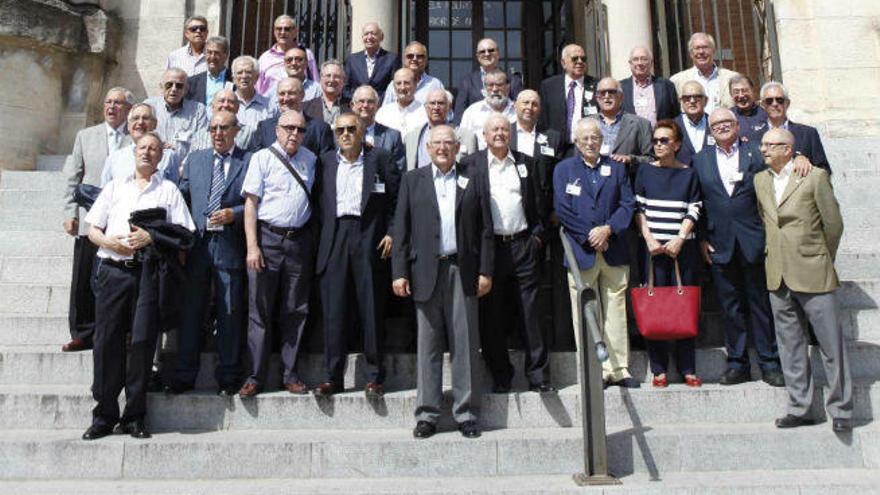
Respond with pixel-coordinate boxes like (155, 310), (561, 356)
(631, 257), (700, 340)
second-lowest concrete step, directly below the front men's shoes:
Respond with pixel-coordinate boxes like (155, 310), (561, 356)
(0, 423), (880, 480)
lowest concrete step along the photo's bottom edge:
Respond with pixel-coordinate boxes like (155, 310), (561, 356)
(4, 469), (880, 495)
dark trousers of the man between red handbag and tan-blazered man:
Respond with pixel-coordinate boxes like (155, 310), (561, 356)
(711, 246), (779, 371)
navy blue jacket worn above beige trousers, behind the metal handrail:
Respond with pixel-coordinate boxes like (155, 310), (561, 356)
(553, 155), (635, 270)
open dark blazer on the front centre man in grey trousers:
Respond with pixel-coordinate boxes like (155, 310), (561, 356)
(391, 165), (495, 302)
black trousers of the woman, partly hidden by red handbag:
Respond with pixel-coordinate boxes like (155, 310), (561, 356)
(642, 240), (702, 375)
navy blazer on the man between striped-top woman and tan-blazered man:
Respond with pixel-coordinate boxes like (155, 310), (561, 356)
(693, 143), (766, 264)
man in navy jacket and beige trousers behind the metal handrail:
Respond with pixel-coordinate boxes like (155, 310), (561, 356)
(553, 119), (639, 387)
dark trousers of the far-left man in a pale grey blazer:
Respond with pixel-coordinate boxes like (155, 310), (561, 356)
(68, 236), (98, 344)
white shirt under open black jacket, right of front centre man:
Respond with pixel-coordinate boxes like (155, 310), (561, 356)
(486, 151), (528, 235)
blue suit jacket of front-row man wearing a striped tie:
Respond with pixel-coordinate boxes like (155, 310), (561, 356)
(179, 147), (251, 270)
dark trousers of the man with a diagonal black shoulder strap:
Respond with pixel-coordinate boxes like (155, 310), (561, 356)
(247, 223), (315, 387)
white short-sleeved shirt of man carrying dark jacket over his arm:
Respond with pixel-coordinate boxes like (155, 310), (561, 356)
(85, 172), (196, 261)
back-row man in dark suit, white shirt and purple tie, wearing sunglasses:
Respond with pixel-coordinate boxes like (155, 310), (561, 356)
(540, 44), (599, 156)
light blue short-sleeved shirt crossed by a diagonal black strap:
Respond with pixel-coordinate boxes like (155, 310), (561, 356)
(241, 142), (317, 228)
